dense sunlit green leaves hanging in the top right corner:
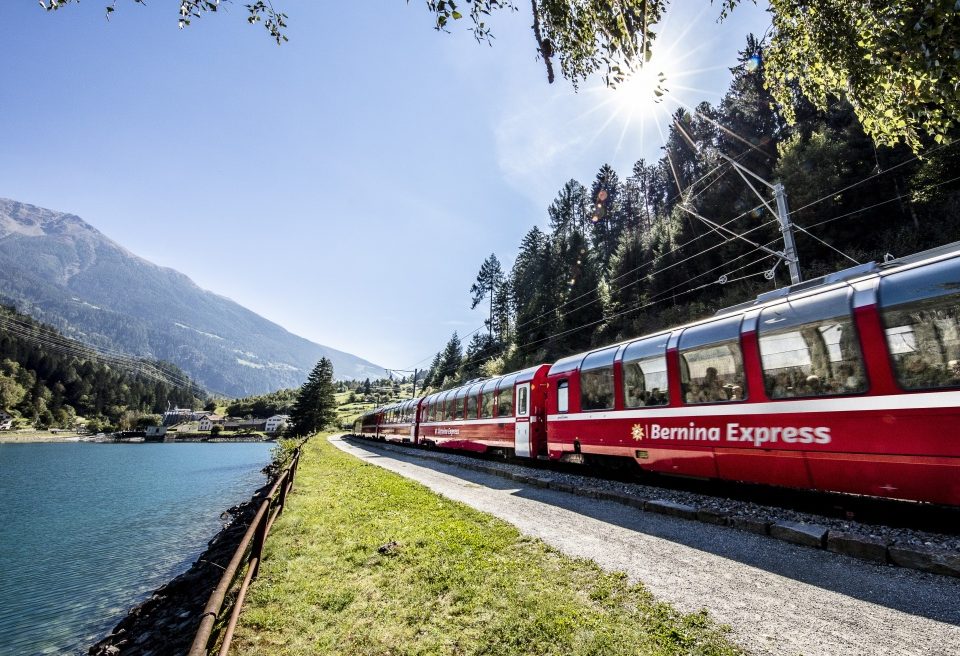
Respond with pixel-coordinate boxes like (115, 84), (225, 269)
(767, 0), (960, 152)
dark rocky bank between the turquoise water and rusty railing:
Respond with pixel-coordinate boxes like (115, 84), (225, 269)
(87, 474), (276, 656)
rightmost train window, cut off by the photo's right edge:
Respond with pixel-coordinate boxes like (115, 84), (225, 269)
(880, 259), (960, 389)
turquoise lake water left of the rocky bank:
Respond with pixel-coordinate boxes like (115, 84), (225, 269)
(0, 443), (271, 656)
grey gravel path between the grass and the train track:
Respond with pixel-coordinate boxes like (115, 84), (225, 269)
(331, 438), (960, 656)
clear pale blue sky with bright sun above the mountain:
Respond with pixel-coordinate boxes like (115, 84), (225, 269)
(0, 0), (770, 369)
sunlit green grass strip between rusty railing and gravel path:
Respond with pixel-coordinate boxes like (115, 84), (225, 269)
(234, 436), (740, 656)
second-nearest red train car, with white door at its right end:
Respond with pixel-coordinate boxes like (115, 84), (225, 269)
(419, 365), (549, 458)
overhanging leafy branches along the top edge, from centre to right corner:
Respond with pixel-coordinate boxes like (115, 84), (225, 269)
(436, 0), (960, 151)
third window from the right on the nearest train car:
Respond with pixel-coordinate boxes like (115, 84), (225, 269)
(680, 316), (747, 403)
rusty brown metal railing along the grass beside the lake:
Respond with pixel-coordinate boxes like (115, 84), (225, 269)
(189, 440), (306, 656)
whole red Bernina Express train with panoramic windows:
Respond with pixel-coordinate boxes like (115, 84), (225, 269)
(355, 242), (960, 505)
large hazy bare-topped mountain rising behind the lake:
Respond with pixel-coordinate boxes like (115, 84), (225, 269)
(0, 198), (383, 397)
